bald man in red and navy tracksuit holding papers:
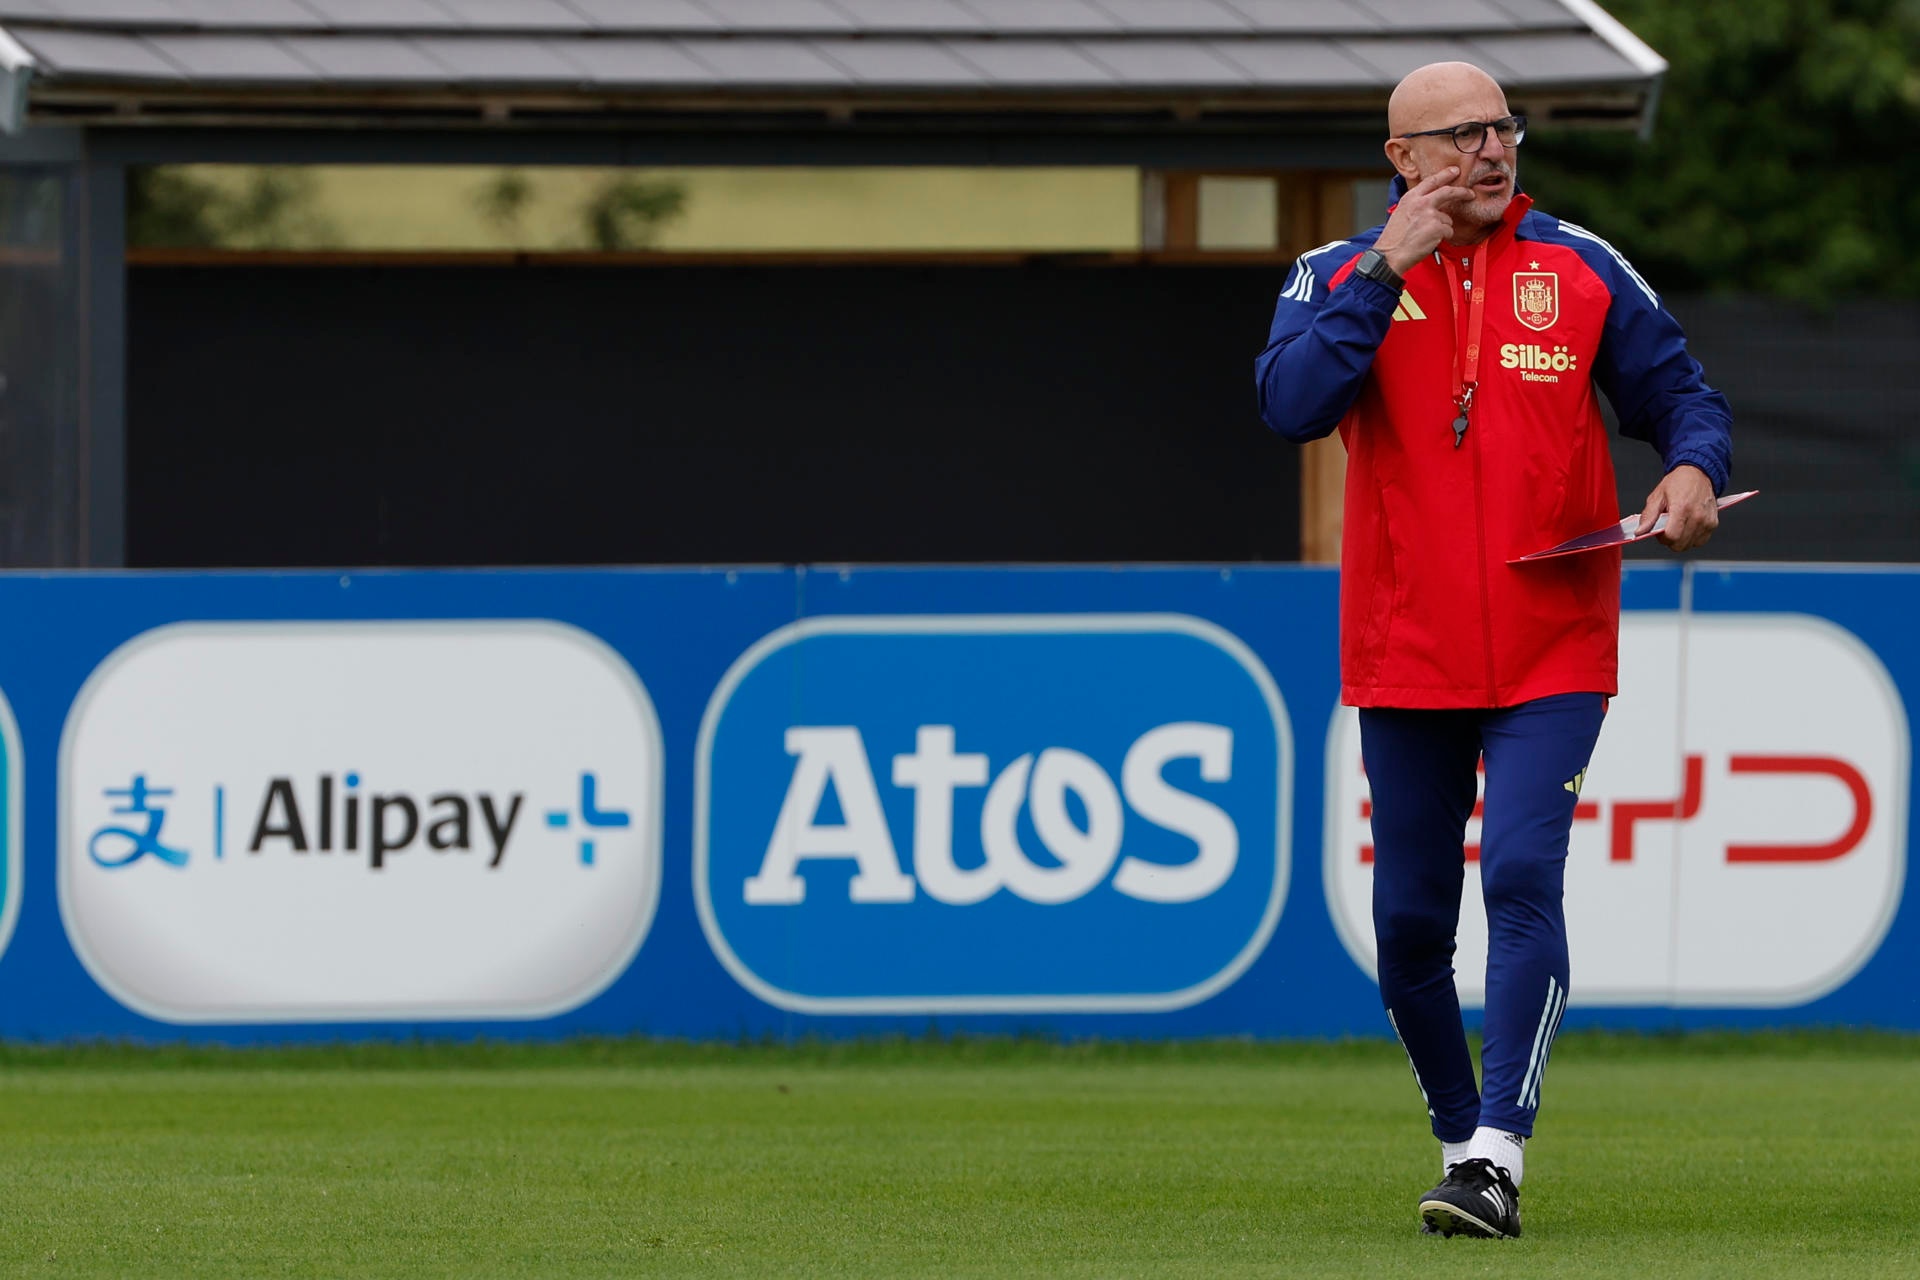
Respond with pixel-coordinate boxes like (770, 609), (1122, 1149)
(1256, 63), (1730, 1238)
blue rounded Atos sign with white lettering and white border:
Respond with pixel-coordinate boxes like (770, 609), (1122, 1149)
(693, 614), (1292, 1013)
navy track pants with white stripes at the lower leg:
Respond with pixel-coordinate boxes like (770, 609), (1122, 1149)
(1359, 693), (1607, 1142)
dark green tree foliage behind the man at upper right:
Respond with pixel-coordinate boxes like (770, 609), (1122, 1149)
(1521, 0), (1920, 303)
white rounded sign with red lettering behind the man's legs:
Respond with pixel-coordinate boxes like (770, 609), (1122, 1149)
(1325, 614), (1910, 1007)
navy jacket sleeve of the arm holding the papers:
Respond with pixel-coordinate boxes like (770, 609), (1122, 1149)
(1559, 223), (1734, 493)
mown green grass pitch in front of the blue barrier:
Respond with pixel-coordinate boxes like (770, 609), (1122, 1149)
(0, 1034), (1920, 1280)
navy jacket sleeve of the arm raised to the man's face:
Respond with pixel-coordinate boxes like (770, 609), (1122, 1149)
(1254, 228), (1400, 443)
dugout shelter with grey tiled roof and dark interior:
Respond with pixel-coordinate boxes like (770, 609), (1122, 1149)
(0, 0), (1665, 568)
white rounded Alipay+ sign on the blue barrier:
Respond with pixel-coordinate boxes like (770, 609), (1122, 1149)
(58, 620), (662, 1023)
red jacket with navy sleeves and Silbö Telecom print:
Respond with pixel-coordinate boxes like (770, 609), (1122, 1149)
(1258, 196), (1730, 708)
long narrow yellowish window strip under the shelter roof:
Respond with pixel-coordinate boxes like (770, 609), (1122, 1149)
(127, 165), (1144, 253)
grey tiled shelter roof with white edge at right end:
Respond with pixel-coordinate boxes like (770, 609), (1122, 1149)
(0, 0), (1665, 125)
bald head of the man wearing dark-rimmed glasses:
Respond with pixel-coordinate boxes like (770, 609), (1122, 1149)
(1386, 61), (1519, 244)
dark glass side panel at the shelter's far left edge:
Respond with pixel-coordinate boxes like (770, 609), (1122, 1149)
(0, 169), (79, 568)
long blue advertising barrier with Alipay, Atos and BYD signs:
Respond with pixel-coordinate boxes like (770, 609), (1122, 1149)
(0, 564), (1920, 1042)
